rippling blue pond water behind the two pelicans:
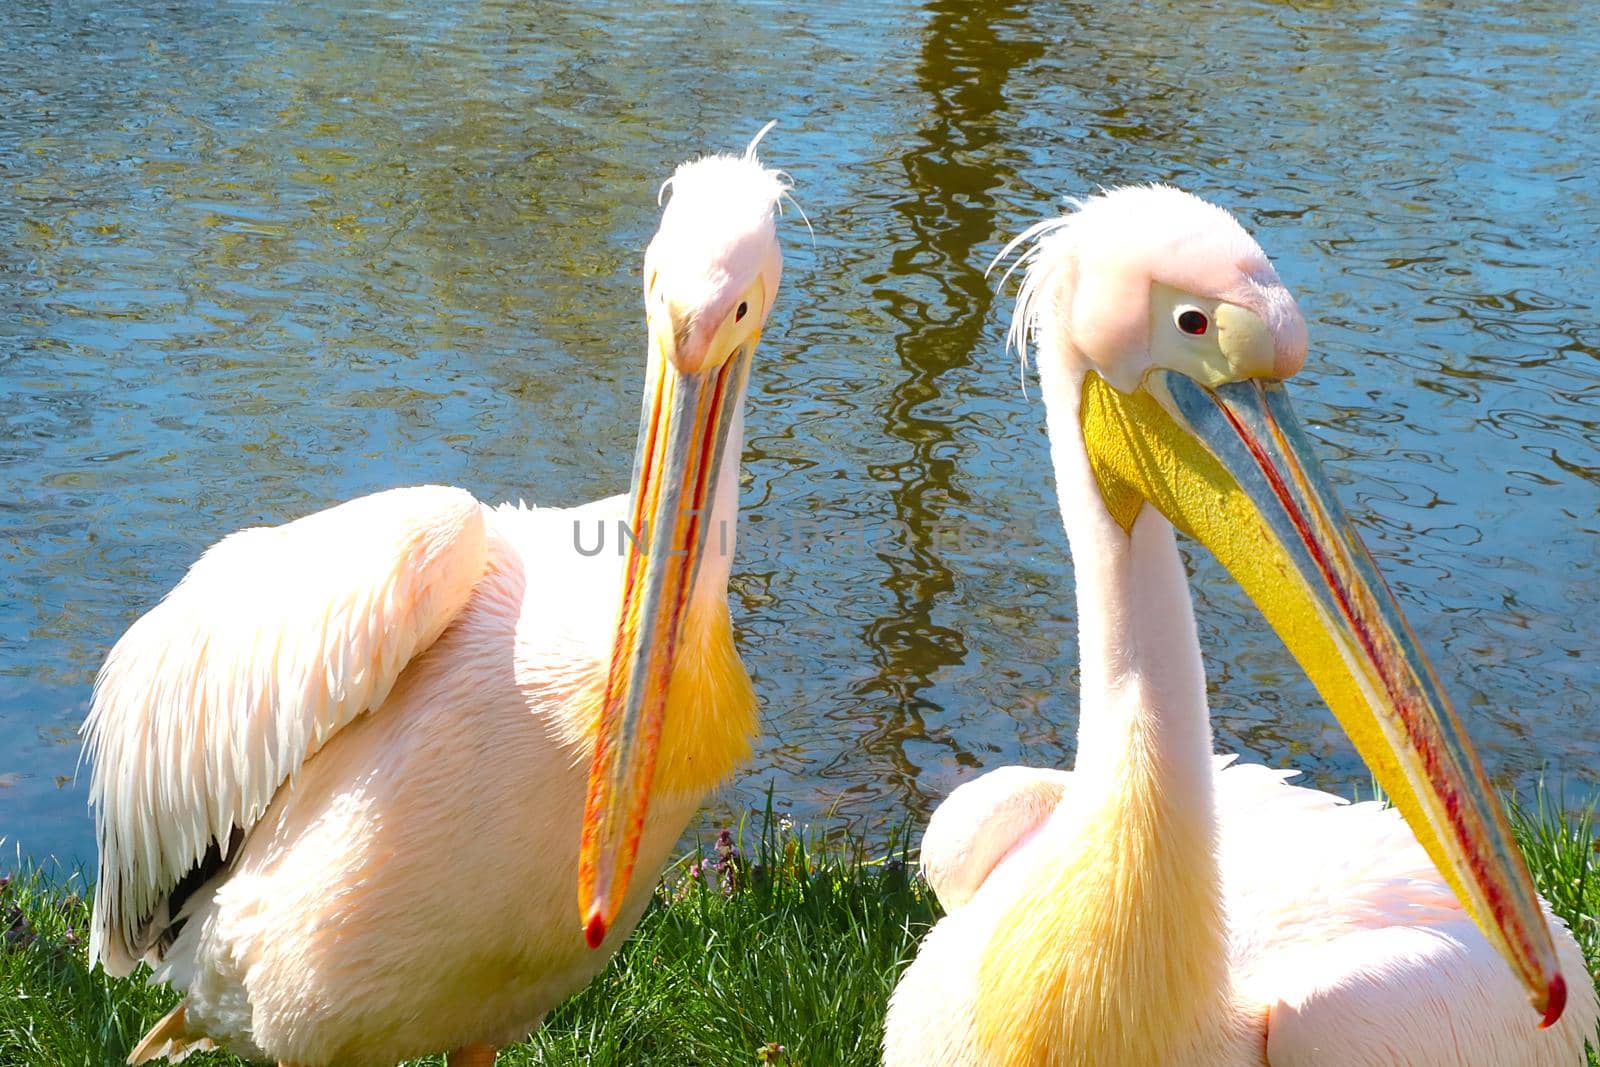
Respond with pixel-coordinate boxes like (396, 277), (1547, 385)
(0, 0), (1600, 861)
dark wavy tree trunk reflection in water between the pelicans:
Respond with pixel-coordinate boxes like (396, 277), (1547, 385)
(854, 0), (1043, 809)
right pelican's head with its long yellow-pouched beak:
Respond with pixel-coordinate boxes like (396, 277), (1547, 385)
(1003, 186), (1566, 1025)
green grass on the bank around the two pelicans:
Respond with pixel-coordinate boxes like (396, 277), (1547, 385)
(0, 795), (1600, 1067)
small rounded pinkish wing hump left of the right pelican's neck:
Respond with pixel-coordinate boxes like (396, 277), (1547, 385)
(922, 766), (1072, 912)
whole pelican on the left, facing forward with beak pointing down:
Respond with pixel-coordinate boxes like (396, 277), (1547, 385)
(85, 130), (787, 1067)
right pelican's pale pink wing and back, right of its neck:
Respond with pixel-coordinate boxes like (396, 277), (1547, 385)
(1216, 765), (1597, 1067)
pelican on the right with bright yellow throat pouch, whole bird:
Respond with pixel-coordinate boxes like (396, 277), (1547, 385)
(885, 187), (1595, 1067)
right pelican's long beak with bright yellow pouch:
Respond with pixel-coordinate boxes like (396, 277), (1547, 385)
(1080, 370), (1566, 1027)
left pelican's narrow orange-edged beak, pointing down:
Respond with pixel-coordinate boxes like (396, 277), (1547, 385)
(578, 301), (758, 949)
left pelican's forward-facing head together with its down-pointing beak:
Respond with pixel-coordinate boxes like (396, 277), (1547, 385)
(578, 125), (789, 947)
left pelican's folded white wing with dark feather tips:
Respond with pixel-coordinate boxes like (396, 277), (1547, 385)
(83, 486), (488, 973)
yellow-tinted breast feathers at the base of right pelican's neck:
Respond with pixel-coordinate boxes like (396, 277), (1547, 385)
(974, 721), (1230, 1067)
